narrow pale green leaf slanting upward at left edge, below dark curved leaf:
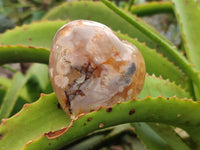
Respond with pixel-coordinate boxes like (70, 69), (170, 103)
(0, 73), (25, 119)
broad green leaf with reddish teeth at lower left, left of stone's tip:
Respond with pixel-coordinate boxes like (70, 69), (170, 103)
(0, 94), (70, 150)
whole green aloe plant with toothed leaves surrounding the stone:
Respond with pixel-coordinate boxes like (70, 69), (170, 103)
(0, 0), (200, 150)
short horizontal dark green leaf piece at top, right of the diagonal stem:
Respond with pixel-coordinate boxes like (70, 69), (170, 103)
(128, 0), (173, 16)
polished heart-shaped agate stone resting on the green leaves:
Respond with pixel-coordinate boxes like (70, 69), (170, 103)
(49, 20), (145, 116)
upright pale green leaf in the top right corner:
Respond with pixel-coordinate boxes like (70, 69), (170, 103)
(171, 0), (200, 70)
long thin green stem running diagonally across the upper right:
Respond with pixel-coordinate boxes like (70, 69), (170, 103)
(101, 0), (200, 96)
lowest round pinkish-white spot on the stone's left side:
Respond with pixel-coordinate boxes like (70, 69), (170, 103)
(54, 75), (69, 88)
